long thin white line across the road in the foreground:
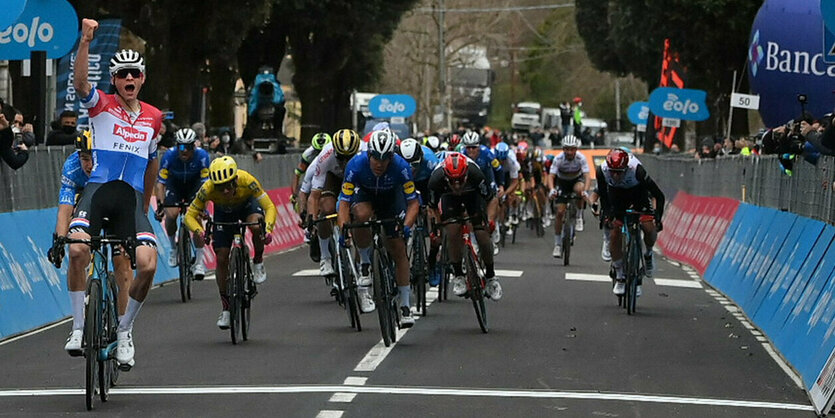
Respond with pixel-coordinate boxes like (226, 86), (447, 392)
(0, 385), (814, 416)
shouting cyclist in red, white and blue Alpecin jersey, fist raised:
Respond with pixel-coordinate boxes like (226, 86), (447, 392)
(67, 19), (162, 371)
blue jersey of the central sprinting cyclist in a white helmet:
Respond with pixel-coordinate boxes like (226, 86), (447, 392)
(339, 151), (417, 202)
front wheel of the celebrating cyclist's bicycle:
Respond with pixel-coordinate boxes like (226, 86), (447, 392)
(84, 280), (102, 411)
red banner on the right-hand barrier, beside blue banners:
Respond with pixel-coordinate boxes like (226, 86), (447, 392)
(658, 191), (739, 274)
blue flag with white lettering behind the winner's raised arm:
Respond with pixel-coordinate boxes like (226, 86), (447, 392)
(55, 19), (122, 128)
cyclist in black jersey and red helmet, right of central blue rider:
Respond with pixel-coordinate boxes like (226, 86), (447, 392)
(429, 152), (502, 301)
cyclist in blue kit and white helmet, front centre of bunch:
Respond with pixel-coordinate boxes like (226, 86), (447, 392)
(339, 129), (420, 328)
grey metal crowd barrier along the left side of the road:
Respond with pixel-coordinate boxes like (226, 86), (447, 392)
(0, 146), (299, 213)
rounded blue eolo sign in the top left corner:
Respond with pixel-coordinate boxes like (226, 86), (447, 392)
(0, 0), (78, 60)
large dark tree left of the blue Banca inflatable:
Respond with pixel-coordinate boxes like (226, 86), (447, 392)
(575, 0), (761, 133)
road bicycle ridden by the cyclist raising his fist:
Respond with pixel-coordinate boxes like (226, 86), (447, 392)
(60, 236), (136, 411)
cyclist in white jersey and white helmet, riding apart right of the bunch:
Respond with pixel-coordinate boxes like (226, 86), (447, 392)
(548, 134), (591, 258)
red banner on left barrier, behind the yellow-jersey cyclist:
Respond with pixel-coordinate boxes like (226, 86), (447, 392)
(153, 187), (304, 270)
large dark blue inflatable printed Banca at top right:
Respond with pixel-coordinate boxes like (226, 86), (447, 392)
(748, 0), (835, 127)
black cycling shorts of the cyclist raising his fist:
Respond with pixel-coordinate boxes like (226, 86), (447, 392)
(70, 180), (157, 248)
